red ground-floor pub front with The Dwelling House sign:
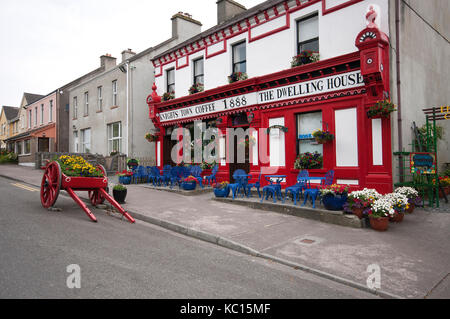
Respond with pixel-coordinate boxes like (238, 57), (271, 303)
(147, 1), (393, 193)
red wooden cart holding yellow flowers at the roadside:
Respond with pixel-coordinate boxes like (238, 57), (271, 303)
(41, 161), (135, 223)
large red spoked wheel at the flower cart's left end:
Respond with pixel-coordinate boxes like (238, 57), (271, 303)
(41, 162), (61, 208)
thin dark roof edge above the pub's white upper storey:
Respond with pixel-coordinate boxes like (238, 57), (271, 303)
(152, 0), (284, 61)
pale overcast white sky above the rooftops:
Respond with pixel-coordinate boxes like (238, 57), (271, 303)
(0, 0), (264, 107)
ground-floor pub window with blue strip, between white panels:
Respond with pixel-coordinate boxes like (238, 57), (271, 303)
(297, 112), (323, 155)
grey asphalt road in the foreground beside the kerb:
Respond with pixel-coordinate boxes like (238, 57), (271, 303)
(0, 178), (374, 299)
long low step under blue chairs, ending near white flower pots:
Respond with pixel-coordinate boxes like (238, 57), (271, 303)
(214, 197), (367, 228)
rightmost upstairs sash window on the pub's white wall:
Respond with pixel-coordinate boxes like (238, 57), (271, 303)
(297, 15), (319, 54)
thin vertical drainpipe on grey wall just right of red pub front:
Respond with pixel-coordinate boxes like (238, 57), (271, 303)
(395, 0), (404, 183)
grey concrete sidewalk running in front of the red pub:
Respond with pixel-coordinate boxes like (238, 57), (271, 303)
(0, 166), (450, 298)
